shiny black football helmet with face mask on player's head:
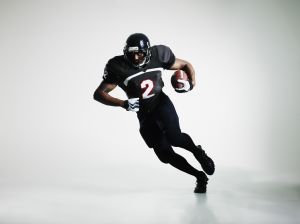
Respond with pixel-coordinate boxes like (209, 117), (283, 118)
(123, 33), (151, 68)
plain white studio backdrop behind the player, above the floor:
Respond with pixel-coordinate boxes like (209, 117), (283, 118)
(0, 0), (300, 188)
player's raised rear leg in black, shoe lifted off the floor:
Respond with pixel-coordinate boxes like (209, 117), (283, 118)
(159, 93), (215, 175)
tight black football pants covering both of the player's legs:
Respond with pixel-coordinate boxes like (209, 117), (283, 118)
(138, 93), (200, 177)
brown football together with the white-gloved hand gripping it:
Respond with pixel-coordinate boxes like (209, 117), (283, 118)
(171, 70), (193, 93)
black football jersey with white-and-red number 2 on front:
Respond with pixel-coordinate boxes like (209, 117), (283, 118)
(103, 45), (175, 111)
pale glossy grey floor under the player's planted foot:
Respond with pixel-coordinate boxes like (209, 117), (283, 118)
(0, 167), (300, 224)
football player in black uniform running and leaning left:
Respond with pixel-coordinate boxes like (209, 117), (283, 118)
(94, 33), (215, 193)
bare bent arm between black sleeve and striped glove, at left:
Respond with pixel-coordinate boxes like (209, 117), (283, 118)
(94, 81), (125, 108)
